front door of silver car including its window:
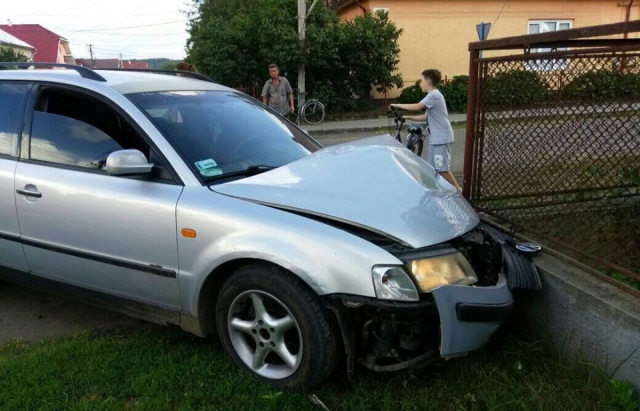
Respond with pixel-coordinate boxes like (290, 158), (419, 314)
(16, 86), (182, 310)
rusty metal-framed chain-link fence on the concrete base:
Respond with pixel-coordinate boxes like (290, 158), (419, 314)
(464, 21), (640, 288)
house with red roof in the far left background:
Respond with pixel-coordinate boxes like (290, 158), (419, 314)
(0, 24), (75, 64)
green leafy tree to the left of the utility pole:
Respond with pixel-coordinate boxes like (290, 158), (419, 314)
(187, 0), (302, 86)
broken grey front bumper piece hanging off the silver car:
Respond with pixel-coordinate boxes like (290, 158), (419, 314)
(432, 274), (513, 357)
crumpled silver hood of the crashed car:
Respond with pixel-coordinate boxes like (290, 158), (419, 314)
(212, 135), (479, 248)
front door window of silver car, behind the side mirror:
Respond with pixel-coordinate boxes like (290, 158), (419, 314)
(30, 88), (150, 170)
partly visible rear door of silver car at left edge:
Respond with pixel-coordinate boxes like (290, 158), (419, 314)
(0, 82), (31, 282)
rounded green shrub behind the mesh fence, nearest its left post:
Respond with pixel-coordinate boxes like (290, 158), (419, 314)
(480, 70), (551, 109)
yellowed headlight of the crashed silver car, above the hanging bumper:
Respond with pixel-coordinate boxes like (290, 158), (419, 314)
(407, 252), (478, 293)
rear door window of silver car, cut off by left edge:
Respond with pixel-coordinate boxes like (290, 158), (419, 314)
(0, 83), (31, 155)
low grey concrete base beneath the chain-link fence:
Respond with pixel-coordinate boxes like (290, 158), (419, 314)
(514, 252), (640, 393)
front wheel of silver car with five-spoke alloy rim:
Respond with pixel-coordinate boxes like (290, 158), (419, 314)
(216, 264), (338, 389)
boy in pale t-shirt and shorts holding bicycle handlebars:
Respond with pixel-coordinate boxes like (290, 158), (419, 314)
(390, 69), (462, 191)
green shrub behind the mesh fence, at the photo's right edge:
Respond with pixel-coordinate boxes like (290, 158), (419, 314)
(562, 70), (640, 101)
